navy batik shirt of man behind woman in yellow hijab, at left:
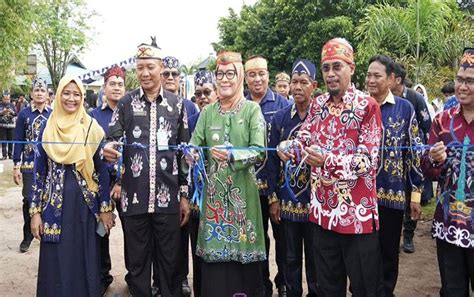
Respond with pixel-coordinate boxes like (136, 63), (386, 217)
(13, 104), (51, 173)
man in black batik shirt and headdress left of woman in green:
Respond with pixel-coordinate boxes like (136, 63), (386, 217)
(104, 38), (189, 297)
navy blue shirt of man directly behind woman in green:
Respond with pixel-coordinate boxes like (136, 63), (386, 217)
(247, 88), (291, 196)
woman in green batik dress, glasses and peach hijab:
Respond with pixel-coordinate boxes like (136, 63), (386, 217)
(191, 52), (266, 297)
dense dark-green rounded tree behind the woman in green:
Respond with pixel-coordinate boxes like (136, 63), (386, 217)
(213, 0), (396, 86)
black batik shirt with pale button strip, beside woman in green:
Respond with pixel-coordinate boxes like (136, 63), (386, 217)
(107, 88), (189, 216)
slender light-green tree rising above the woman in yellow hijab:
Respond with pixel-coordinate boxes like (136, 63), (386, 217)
(33, 0), (95, 89)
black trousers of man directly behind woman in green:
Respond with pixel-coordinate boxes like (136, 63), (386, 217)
(260, 196), (285, 296)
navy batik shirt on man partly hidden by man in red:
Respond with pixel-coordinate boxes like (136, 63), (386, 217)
(267, 104), (311, 222)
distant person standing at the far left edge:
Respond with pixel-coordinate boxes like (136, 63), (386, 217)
(0, 92), (16, 160)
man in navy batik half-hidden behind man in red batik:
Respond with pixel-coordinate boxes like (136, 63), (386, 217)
(268, 59), (317, 297)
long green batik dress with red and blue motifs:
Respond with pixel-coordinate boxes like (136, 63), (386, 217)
(191, 98), (266, 264)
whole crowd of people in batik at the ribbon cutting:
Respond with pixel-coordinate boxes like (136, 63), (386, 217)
(4, 38), (474, 297)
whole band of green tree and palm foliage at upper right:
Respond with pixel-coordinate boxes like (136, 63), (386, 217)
(217, 0), (474, 89)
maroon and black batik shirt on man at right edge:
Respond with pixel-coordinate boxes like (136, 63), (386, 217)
(422, 105), (474, 249)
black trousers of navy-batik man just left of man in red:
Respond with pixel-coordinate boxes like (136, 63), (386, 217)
(280, 220), (317, 297)
